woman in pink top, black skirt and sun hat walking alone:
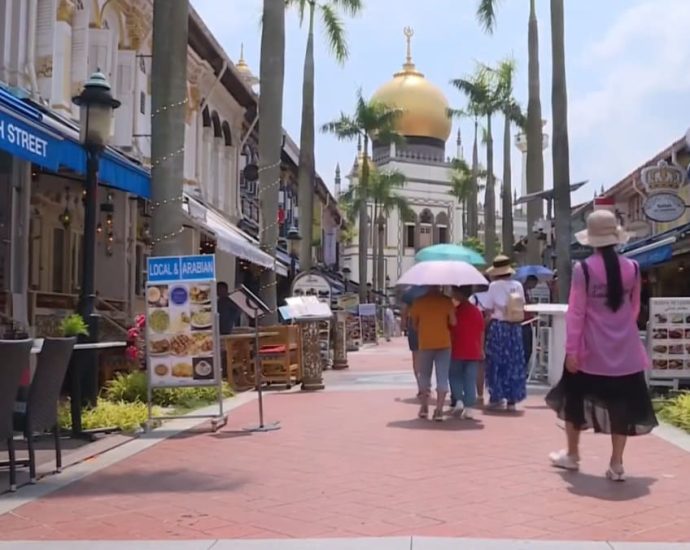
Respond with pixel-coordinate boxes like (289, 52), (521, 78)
(546, 210), (657, 481)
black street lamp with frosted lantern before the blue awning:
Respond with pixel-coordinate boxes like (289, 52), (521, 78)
(72, 70), (120, 328)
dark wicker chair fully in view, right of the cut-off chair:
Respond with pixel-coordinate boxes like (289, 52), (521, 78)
(14, 338), (77, 483)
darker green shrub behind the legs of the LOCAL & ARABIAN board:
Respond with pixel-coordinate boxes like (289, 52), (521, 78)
(103, 371), (233, 409)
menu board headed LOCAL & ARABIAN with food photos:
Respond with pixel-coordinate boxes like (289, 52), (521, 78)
(146, 255), (220, 388)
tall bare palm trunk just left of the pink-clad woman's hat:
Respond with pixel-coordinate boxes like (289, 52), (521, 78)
(551, 0), (572, 303)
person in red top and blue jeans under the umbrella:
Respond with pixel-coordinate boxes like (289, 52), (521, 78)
(449, 286), (484, 419)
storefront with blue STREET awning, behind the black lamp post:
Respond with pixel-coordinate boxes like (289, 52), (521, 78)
(0, 88), (150, 336)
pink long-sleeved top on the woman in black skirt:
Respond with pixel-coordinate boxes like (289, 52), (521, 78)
(566, 254), (650, 376)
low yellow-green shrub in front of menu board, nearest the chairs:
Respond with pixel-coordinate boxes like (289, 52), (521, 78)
(58, 399), (160, 432)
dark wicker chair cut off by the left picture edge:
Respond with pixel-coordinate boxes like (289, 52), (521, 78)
(0, 339), (33, 491)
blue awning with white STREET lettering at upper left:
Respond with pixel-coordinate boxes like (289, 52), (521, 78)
(0, 87), (151, 198)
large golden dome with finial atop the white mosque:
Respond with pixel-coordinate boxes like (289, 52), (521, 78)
(371, 27), (452, 142)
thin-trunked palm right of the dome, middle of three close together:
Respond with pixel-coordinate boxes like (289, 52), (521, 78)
(451, 65), (502, 259)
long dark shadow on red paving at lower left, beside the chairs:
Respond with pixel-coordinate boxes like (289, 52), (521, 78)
(39, 469), (246, 499)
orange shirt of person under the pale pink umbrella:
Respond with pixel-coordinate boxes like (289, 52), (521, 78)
(409, 293), (455, 350)
